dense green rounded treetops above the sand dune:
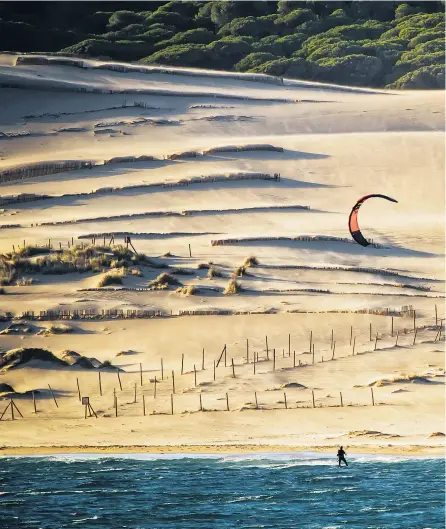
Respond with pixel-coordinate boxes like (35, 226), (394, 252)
(0, 1), (445, 89)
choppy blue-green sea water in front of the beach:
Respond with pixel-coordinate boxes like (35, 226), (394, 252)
(0, 454), (445, 529)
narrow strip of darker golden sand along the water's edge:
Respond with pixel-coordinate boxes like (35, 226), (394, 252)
(0, 443), (445, 457)
